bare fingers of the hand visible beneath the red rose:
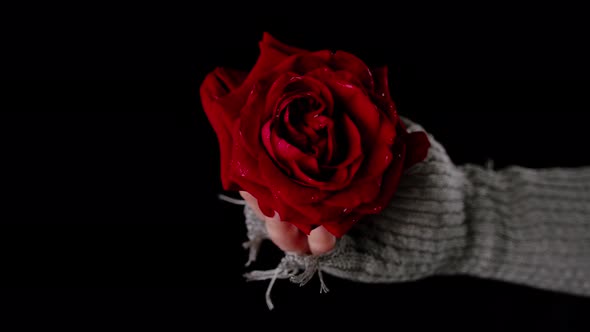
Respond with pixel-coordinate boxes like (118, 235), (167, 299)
(240, 191), (336, 255)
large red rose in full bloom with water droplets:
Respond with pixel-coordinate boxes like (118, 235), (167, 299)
(201, 34), (430, 237)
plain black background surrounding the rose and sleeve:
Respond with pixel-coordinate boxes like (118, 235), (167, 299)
(0, 4), (590, 331)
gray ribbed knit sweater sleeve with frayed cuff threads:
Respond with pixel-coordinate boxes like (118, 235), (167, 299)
(245, 119), (590, 307)
